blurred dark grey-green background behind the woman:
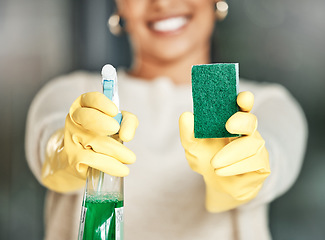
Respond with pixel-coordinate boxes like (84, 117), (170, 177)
(0, 0), (325, 240)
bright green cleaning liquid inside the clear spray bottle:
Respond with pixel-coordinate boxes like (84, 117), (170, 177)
(81, 195), (123, 240)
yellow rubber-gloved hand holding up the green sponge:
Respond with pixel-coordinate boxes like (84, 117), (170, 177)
(179, 92), (270, 212)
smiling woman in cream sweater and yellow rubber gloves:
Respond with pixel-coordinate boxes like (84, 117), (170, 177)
(26, 0), (307, 240)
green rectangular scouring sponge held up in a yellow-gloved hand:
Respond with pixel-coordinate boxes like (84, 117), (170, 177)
(192, 63), (239, 138)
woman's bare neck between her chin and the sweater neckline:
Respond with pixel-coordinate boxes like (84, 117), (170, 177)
(129, 44), (210, 84)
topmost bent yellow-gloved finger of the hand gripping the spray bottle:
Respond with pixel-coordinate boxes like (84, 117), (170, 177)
(80, 92), (118, 117)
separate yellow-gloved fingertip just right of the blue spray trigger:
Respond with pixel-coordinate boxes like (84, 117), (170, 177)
(119, 111), (139, 142)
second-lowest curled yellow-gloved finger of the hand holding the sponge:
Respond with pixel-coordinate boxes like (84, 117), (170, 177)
(211, 136), (265, 169)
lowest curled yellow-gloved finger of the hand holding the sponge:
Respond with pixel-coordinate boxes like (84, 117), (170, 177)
(215, 148), (270, 177)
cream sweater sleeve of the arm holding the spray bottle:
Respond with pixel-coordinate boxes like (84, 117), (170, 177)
(25, 72), (100, 183)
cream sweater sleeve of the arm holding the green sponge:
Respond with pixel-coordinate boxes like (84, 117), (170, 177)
(240, 84), (308, 208)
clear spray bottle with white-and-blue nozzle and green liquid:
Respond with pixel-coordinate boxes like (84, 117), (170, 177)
(79, 64), (128, 240)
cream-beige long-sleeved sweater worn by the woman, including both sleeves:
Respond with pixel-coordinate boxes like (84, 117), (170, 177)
(26, 70), (307, 240)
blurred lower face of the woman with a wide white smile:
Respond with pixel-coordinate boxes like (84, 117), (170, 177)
(117, 0), (215, 62)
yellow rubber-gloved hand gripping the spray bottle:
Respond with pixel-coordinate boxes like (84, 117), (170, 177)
(42, 92), (138, 192)
